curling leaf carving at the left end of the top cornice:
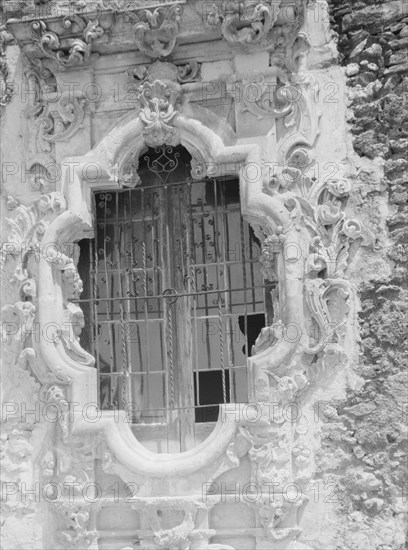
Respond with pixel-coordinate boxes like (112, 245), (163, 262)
(31, 15), (104, 70)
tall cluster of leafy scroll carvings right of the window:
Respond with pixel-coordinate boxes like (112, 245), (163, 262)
(254, 153), (362, 398)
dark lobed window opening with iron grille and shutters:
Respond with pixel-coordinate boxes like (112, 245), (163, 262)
(79, 145), (272, 450)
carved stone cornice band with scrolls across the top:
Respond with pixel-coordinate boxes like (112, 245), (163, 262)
(6, 0), (310, 71)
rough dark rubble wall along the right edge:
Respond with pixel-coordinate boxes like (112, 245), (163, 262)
(321, 0), (408, 550)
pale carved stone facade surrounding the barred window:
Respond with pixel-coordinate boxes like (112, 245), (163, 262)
(1, 0), (402, 550)
